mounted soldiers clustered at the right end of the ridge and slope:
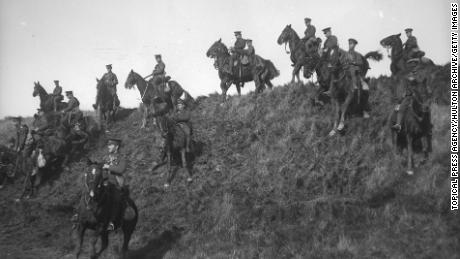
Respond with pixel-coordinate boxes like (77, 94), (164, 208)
(278, 18), (435, 174)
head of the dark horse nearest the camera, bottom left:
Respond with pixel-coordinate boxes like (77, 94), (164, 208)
(85, 160), (104, 201)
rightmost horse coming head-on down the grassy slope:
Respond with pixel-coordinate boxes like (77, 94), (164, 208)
(388, 82), (433, 175)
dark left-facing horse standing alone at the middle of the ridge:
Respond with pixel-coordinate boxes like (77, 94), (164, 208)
(206, 39), (279, 101)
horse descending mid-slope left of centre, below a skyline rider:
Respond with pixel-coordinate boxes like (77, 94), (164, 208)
(150, 99), (192, 187)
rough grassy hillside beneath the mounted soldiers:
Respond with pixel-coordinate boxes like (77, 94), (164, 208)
(0, 74), (454, 258)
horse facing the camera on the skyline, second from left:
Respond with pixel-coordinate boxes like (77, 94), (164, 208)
(95, 78), (117, 127)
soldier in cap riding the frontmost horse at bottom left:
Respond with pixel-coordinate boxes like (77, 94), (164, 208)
(102, 138), (129, 231)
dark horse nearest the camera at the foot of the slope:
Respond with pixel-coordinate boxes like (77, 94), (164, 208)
(76, 162), (139, 259)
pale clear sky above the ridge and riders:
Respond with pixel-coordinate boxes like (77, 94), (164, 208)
(0, 0), (451, 118)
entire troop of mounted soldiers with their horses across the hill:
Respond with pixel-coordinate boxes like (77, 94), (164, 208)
(0, 18), (438, 255)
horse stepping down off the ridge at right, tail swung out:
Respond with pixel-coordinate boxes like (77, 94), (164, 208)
(329, 48), (382, 136)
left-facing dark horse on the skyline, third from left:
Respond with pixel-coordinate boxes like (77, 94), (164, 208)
(125, 69), (193, 128)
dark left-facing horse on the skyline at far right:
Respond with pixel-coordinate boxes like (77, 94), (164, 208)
(380, 33), (434, 76)
